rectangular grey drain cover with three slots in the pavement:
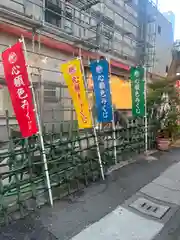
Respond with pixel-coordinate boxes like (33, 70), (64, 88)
(129, 198), (170, 219)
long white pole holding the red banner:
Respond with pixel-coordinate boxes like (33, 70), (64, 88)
(20, 36), (53, 206)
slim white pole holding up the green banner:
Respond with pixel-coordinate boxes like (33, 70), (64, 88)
(144, 65), (148, 154)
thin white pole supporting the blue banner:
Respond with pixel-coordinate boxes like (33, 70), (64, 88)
(108, 58), (117, 165)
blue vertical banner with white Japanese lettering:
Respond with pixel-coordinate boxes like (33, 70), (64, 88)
(90, 59), (113, 123)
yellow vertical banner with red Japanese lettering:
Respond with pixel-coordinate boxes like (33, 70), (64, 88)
(61, 59), (92, 129)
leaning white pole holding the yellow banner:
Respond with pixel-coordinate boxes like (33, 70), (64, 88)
(79, 54), (105, 180)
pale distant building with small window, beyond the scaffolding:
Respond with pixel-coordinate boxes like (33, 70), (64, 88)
(147, 3), (174, 76)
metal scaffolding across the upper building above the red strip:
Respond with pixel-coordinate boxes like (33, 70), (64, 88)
(0, 0), (139, 65)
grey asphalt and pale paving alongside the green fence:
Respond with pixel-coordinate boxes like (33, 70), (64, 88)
(0, 149), (180, 240)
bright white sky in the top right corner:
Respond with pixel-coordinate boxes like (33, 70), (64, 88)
(158, 0), (180, 40)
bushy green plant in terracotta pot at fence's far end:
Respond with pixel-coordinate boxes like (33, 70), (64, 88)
(147, 78), (179, 151)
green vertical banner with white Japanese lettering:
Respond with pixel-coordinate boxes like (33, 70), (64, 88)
(130, 67), (145, 117)
